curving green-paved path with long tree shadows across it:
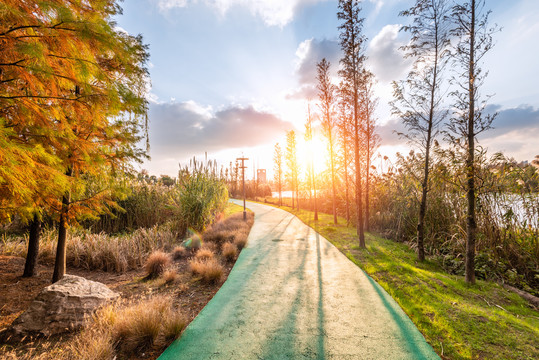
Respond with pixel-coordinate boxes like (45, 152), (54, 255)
(159, 203), (439, 360)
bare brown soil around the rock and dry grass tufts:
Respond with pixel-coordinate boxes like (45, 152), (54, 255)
(0, 249), (238, 359)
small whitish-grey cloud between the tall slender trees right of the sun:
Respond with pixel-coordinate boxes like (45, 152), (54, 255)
(367, 24), (411, 82)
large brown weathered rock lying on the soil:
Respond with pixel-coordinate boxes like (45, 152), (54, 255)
(10, 275), (119, 337)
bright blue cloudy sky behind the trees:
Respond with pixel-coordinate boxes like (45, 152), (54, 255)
(115, 0), (539, 177)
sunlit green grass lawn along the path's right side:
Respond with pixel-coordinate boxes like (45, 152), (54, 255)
(264, 202), (539, 359)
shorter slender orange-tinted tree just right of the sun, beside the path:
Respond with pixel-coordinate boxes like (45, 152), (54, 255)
(316, 58), (337, 224)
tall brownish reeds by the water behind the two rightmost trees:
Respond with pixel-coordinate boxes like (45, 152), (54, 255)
(370, 149), (539, 294)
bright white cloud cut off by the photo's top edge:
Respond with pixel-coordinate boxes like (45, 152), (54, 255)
(157, 0), (327, 27)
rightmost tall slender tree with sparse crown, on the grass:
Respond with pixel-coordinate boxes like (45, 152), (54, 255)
(448, 0), (498, 284)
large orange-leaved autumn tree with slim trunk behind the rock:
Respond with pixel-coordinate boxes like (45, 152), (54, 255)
(0, 0), (148, 282)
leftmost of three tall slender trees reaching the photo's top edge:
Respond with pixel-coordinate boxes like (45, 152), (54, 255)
(337, 0), (366, 248)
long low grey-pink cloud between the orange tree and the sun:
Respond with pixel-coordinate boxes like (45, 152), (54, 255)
(150, 101), (292, 160)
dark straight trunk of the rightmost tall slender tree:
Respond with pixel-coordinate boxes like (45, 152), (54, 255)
(466, 0), (477, 284)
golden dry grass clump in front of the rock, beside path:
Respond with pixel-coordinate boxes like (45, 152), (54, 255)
(0, 296), (187, 360)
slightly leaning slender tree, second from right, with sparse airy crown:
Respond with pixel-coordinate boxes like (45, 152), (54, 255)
(392, 0), (450, 261)
